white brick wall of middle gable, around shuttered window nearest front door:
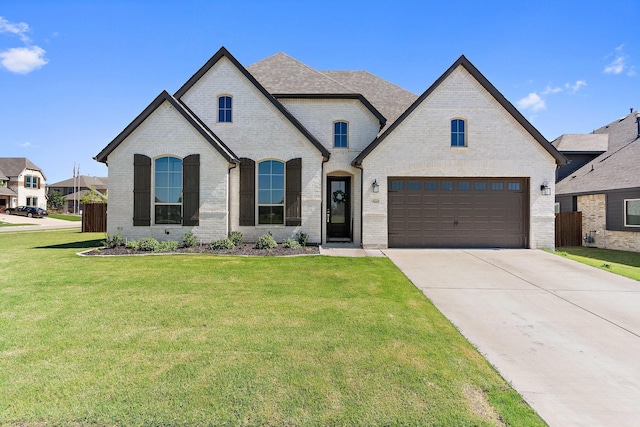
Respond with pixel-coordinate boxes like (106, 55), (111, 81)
(181, 57), (322, 243)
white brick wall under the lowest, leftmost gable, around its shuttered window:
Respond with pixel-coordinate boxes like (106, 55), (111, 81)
(107, 98), (229, 242)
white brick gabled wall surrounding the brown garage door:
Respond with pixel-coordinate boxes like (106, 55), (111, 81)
(363, 67), (556, 248)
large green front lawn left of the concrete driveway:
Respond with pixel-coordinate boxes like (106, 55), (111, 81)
(0, 230), (545, 426)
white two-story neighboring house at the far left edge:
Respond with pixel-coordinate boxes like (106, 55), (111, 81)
(0, 157), (47, 213)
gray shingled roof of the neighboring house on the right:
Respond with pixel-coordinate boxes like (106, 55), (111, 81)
(556, 113), (640, 194)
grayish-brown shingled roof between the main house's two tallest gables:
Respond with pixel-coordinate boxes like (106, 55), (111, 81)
(247, 53), (418, 132)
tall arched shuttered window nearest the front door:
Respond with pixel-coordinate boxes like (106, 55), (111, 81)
(258, 160), (284, 225)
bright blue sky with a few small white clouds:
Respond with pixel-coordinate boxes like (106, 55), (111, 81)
(0, 0), (640, 183)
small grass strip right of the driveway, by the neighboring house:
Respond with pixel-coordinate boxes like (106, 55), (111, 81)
(556, 246), (640, 281)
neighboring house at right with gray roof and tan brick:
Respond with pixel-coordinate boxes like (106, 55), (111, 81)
(556, 112), (640, 252)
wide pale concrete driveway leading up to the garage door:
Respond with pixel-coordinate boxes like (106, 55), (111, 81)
(384, 249), (640, 426)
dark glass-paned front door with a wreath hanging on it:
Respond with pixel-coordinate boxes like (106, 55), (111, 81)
(327, 176), (351, 241)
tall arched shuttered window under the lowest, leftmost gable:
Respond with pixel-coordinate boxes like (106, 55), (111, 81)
(153, 157), (182, 224)
